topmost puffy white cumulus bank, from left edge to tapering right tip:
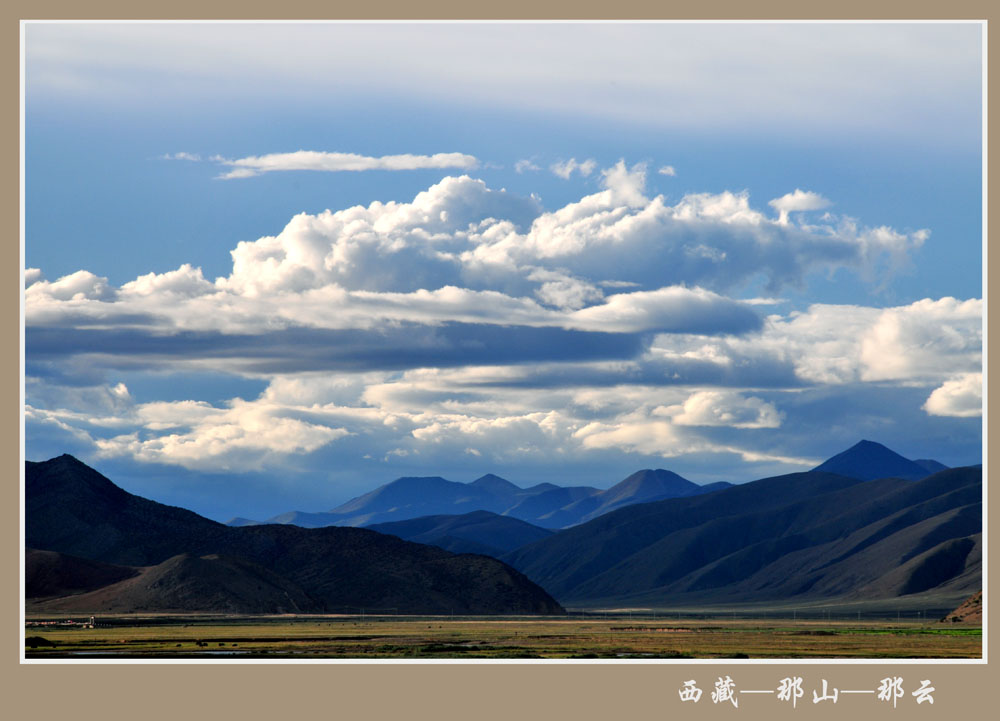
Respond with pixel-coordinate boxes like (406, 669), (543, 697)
(26, 167), (927, 325)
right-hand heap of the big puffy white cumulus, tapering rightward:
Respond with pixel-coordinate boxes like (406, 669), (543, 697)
(461, 162), (927, 290)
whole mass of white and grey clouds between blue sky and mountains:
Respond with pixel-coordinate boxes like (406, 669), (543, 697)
(25, 167), (983, 484)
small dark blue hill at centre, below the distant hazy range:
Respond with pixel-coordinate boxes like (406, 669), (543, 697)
(366, 511), (553, 556)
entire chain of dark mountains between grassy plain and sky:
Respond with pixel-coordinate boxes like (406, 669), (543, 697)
(25, 441), (982, 613)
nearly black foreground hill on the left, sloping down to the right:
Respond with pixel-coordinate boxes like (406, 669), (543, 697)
(25, 455), (562, 613)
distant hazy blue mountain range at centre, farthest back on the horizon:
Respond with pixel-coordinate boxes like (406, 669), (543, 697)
(236, 469), (731, 529)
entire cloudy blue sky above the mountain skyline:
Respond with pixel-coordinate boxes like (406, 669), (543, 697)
(22, 22), (984, 521)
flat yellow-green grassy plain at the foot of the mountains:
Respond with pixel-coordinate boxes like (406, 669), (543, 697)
(25, 615), (982, 660)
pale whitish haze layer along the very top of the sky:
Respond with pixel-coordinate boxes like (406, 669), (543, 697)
(26, 22), (982, 142)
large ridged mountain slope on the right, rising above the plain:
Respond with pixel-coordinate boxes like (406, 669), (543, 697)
(503, 467), (982, 605)
